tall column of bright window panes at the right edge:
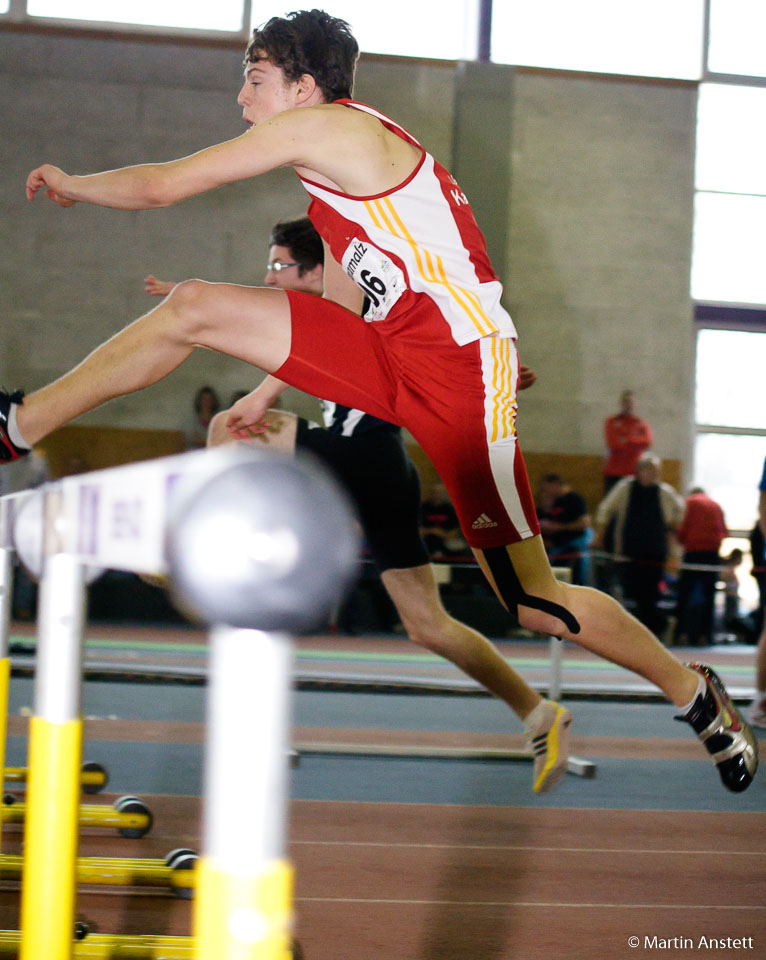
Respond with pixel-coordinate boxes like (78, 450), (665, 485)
(691, 0), (766, 530)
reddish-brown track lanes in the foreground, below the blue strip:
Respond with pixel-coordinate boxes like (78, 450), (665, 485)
(0, 797), (766, 960)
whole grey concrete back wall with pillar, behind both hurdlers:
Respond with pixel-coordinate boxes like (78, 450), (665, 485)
(0, 32), (696, 480)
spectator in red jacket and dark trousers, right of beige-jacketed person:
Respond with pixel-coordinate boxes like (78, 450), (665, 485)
(675, 487), (729, 647)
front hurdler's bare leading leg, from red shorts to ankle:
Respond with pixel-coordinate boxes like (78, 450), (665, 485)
(17, 280), (291, 445)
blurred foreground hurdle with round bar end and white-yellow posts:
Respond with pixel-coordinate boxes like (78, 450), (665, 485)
(14, 445), (358, 960)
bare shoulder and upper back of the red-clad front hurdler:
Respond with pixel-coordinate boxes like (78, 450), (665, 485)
(294, 103), (422, 196)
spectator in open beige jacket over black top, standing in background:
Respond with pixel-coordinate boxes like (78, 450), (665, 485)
(594, 453), (684, 635)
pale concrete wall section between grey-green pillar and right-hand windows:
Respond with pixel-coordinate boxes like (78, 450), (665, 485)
(506, 72), (696, 474)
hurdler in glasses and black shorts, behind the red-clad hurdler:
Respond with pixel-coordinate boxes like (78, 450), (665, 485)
(145, 217), (572, 793)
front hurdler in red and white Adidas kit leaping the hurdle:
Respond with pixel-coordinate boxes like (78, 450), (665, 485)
(0, 10), (758, 791)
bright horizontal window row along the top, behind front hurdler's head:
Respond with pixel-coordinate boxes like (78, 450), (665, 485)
(0, 0), (711, 72)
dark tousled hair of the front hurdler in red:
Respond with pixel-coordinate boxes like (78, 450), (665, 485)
(245, 10), (359, 103)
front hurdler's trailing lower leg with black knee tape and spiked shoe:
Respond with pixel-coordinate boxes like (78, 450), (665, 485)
(474, 537), (758, 792)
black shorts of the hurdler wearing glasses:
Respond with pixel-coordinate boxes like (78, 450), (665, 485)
(296, 417), (430, 573)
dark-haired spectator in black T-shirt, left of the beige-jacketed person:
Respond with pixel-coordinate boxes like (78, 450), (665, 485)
(537, 473), (593, 584)
